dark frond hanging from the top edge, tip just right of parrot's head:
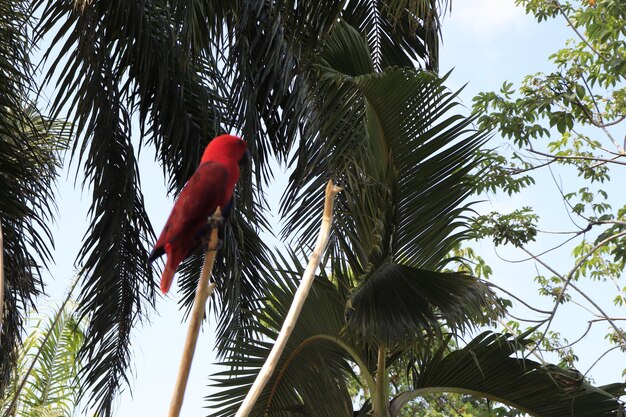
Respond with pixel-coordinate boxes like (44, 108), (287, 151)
(225, 0), (343, 171)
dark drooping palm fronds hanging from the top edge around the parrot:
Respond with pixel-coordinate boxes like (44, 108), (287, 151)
(33, 0), (439, 415)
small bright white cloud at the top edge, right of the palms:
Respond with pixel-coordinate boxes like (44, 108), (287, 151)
(444, 0), (529, 37)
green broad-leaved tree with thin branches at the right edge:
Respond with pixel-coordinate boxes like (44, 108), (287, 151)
(473, 0), (626, 384)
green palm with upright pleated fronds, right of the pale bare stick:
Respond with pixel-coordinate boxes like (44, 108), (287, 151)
(206, 23), (625, 417)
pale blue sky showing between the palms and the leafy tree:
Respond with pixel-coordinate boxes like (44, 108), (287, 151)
(35, 0), (623, 417)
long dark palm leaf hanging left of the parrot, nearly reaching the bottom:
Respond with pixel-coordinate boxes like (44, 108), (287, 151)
(32, 5), (154, 406)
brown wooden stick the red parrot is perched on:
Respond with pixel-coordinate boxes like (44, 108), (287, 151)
(167, 207), (221, 417)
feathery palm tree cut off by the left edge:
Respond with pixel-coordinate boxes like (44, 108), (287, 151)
(0, 1), (68, 397)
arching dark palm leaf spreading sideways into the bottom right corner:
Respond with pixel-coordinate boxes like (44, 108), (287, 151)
(391, 332), (626, 417)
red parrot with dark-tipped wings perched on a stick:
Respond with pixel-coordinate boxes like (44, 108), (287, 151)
(148, 135), (248, 294)
